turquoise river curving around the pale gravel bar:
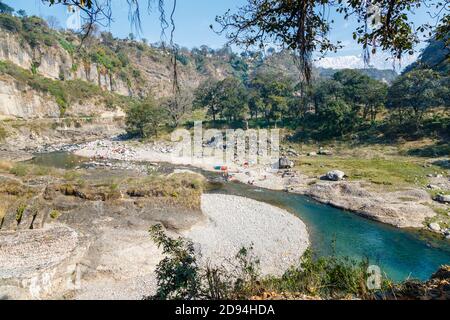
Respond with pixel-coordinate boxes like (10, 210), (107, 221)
(32, 153), (450, 280)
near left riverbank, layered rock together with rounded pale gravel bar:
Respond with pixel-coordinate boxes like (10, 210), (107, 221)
(0, 169), (309, 299)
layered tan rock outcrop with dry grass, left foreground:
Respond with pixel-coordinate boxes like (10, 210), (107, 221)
(0, 171), (203, 299)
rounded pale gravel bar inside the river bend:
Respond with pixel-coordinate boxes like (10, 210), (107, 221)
(183, 194), (309, 275)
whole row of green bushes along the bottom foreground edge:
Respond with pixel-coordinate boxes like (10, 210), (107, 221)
(149, 230), (389, 300)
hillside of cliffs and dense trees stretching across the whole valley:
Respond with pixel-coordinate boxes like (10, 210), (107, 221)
(0, 14), (450, 142)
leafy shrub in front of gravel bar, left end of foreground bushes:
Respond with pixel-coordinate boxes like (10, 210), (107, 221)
(147, 225), (259, 300)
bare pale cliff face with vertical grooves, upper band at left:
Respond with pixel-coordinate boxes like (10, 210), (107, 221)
(0, 30), (231, 106)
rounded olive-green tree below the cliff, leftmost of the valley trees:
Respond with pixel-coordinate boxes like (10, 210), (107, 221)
(126, 97), (167, 138)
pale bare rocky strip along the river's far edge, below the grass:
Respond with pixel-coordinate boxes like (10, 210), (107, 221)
(75, 140), (449, 237)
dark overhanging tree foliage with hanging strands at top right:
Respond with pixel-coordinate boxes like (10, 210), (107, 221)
(216, 0), (449, 83)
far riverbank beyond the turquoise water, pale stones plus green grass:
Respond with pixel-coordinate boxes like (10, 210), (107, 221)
(76, 140), (450, 238)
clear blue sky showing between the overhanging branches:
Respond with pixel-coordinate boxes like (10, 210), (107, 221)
(3, 0), (438, 69)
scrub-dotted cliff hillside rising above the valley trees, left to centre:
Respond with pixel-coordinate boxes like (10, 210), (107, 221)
(0, 13), (400, 97)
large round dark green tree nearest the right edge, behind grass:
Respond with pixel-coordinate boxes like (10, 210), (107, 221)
(387, 69), (445, 129)
